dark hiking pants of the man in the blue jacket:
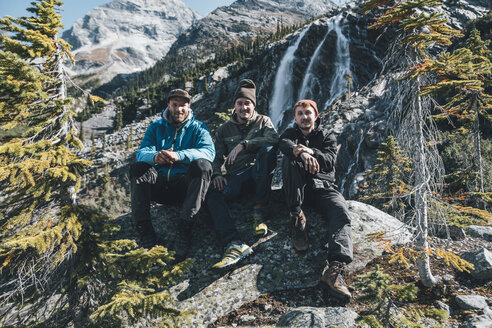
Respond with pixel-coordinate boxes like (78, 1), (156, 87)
(130, 159), (212, 232)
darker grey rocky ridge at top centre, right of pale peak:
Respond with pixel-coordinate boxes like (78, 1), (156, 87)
(169, 0), (336, 58)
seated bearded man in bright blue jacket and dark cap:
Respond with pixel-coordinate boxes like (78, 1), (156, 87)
(130, 89), (215, 260)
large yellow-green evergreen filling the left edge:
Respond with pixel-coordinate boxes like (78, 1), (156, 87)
(0, 0), (190, 327)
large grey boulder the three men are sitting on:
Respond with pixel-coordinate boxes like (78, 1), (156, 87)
(116, 197), (409, 326)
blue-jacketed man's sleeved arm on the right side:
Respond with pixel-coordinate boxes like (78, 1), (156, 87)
(175, 123), (215, 163)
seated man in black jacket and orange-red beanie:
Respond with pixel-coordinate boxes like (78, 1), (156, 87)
(279, 100), (353, 301)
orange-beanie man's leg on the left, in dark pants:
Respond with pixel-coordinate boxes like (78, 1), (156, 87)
(282, 157), (308, 251)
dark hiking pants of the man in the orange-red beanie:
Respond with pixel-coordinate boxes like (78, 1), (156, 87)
(282, 157), (353, 263)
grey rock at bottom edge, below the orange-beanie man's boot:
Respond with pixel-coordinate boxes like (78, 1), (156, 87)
(277, 307), (358, 328)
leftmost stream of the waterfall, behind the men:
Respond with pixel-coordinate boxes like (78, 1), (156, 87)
(270, 26), (309, 127)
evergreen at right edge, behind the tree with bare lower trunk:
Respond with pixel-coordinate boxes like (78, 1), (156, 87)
(419, 29), (492, 205)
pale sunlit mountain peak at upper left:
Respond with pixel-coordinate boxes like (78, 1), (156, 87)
(62, 0), (201, 82)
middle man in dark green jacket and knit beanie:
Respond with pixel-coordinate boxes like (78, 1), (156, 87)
(206, 79), (278, 268)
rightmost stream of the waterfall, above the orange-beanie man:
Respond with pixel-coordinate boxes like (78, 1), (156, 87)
(323, 20), (352, 109)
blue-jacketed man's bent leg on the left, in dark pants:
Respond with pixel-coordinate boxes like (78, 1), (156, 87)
(130, 162), (161, 248)
